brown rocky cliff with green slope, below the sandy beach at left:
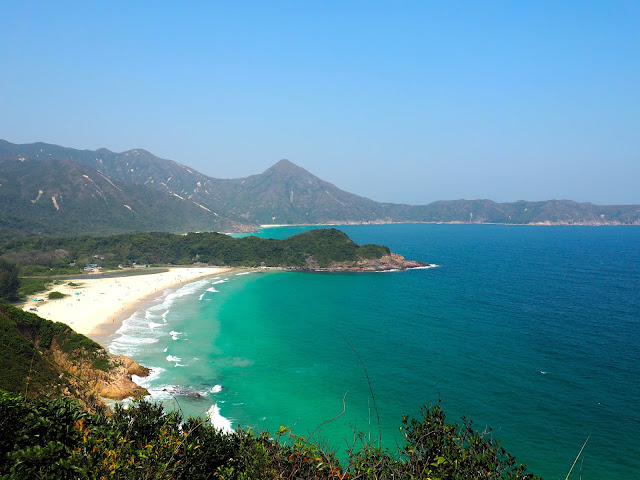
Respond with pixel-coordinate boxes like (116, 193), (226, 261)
(0, 303), (149, 412)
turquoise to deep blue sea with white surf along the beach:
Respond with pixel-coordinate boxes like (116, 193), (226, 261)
(110, 225), (640, 480)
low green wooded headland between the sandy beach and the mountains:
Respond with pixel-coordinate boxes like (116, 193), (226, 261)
(0, 228), (389, 275)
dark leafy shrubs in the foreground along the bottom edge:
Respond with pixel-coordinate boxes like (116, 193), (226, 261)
(0, 391), (539, 480)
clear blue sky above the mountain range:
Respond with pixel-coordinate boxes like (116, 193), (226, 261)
(0, 0), (640, 204)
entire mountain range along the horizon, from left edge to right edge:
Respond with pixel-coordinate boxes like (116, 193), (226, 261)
(0, 140), (640, 234)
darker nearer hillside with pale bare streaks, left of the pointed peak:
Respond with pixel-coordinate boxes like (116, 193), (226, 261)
(0, 152), (252, 240)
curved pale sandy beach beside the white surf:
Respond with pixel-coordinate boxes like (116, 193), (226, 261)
(22, 267), (234, 343)
